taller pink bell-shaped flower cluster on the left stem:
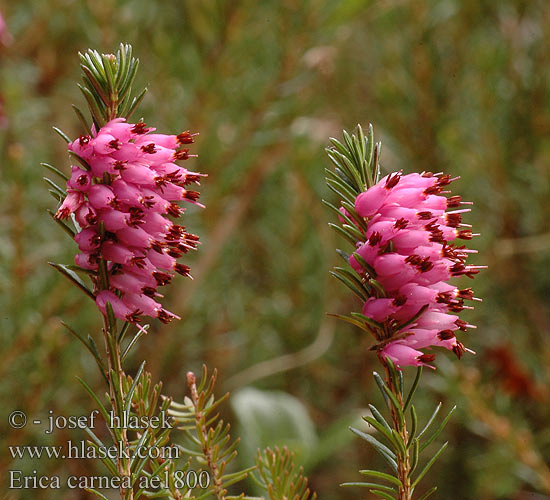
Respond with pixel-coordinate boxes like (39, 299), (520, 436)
(55, 118), (202, 323)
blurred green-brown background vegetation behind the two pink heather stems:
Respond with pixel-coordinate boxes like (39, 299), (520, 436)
(0, 0), (550, 500)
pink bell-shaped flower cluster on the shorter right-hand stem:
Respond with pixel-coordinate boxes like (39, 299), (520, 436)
(350, 173), (484, 366)
